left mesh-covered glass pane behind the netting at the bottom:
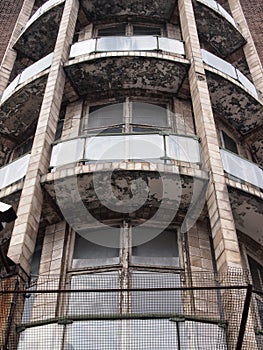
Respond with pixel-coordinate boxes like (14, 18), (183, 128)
(68, 272), (119, 316)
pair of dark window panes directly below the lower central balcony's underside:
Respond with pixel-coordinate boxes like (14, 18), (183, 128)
(72, 227), (180, 269)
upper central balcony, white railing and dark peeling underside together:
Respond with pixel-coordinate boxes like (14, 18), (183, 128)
(65, 36), (189, 96)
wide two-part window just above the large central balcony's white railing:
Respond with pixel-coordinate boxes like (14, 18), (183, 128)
(82, 98), (170, 133)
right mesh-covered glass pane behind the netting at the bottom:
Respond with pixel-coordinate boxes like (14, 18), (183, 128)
(131, 271), (183, 314)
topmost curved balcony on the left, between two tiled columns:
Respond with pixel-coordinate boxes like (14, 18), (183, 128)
(14, 0), (65, 61)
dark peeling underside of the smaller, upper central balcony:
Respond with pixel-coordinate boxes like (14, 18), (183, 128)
(65, 54), (188, 96)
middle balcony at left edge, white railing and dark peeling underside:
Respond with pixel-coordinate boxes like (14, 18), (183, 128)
(0, 53), (53, 137)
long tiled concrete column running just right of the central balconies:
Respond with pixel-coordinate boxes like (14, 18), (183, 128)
(179, 0), (241, 272)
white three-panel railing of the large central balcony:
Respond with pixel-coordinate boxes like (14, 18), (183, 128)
(50, 134), (200, 168)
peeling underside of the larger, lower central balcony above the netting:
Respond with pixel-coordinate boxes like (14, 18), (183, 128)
(42, 163), (206, 224)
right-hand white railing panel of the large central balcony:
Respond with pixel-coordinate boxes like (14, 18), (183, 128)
(165, 135), (201, 163)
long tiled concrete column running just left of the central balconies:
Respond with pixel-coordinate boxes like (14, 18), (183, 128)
(8, 0), (79, 272)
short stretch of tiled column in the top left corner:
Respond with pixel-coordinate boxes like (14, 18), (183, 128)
(0, 0), (34, 95)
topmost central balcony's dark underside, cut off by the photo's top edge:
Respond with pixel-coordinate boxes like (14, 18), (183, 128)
(80, 0), (178, 22)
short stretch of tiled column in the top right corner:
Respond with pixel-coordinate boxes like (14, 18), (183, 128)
(228, 0), (263, 93)
